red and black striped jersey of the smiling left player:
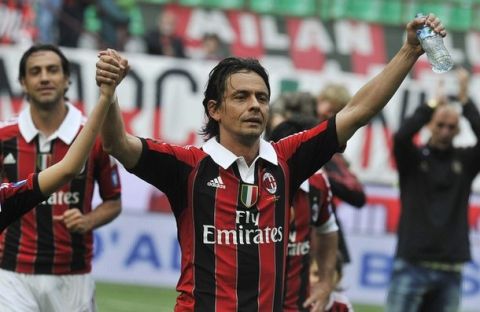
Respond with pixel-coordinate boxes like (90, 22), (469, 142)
(0, 104), (120, 274)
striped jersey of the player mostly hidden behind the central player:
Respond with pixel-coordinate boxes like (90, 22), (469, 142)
(283, 172), (338, 312)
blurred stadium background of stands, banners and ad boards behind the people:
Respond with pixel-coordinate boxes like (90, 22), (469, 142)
(0, 0), (480, 311)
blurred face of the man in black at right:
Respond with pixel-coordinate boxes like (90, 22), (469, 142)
(429, 106), (459, 149)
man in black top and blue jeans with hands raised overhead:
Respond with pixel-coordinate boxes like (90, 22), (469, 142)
(386, 68), (480, 312)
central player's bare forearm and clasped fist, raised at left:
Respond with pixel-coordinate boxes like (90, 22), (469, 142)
(96, 50), (142, 169)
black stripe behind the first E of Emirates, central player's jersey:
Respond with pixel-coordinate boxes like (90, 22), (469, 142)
(194, 157), (219, 311)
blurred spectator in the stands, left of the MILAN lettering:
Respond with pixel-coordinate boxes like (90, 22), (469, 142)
(145, 10), (185, 58)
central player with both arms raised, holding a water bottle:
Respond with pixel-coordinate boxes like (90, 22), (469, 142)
(97, 15), (446, 311)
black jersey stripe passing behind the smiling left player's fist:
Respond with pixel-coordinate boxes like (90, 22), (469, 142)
(69, 160), (91, 272)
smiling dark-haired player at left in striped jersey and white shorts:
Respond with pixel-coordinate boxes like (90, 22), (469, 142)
(0, 45), (120, 312)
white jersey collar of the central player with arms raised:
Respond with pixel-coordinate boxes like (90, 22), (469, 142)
(202, 138), (278, 169)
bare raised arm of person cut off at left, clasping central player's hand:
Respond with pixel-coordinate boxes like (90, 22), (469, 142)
(38, 71), (119, 195)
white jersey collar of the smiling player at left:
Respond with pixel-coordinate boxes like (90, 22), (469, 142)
(18, 103), (82, 145)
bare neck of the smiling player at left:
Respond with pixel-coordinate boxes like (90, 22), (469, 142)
(30, 103), (68, 137)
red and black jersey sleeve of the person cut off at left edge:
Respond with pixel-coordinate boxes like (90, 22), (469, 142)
(0, 173), (46, 232)
